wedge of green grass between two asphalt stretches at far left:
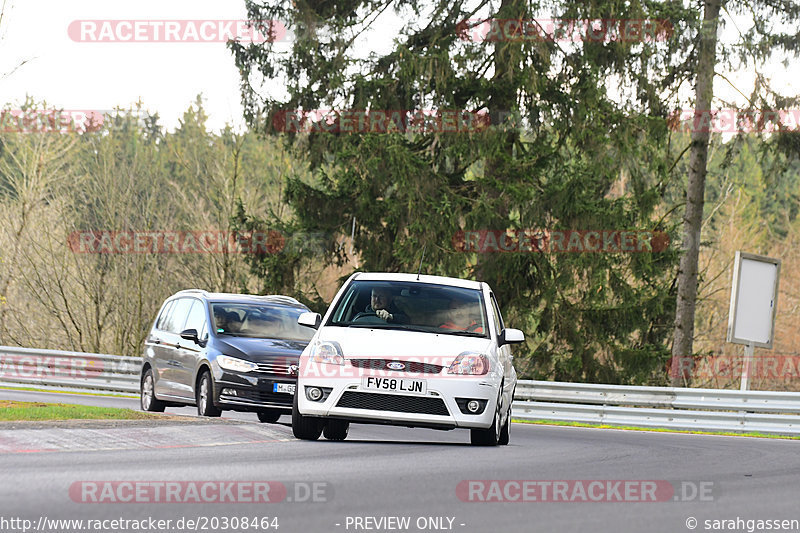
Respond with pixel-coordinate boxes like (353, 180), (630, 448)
(0, 400), (163, 422)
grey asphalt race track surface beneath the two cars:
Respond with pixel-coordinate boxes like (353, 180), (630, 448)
(0, 390), (800, 533)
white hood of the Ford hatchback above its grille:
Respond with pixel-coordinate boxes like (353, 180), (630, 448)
(319, 326), (492, 364)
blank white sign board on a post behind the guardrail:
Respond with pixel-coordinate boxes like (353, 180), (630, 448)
(728, 252), (781, 348)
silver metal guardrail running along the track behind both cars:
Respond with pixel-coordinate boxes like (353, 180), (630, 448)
(0, 346), (800, 435)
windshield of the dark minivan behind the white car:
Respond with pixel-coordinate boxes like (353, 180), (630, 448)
(211, 302), (314, 342)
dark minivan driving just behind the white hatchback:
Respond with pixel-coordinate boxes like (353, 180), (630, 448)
(140, 289), (314, 422)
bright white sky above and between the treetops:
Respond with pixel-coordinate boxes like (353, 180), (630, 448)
(0, 0), (800, 130)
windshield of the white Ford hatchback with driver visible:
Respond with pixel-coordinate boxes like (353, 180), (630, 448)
(327, 280), (489, 337)
